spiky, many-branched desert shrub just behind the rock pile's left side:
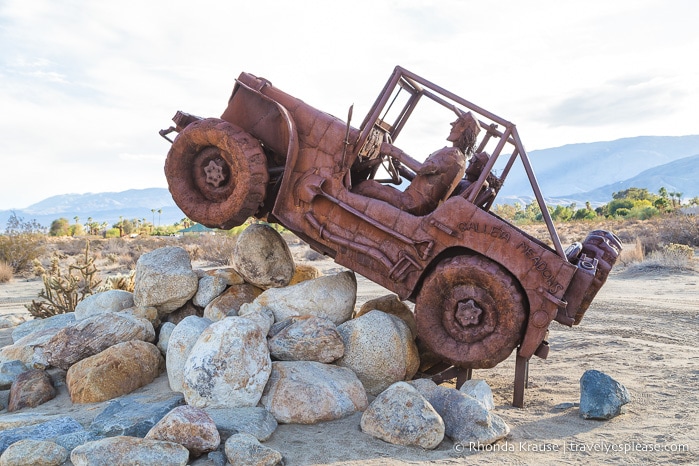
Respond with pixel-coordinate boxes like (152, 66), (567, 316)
(25, 241), (101, 319)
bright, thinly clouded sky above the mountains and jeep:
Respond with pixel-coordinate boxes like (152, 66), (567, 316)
(0, 0), (699, 210)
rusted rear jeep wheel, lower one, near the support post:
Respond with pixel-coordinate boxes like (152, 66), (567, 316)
(415, 255), (527, 369)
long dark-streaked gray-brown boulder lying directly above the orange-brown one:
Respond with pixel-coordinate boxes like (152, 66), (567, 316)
(44, 312), (155, 370)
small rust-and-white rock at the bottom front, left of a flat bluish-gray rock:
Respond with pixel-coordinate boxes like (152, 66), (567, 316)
(145, 406), (221, 457)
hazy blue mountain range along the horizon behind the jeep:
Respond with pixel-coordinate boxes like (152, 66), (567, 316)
(0, 135), (699, 231)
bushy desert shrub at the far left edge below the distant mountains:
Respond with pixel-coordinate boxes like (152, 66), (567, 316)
(0, 213), (46, 274)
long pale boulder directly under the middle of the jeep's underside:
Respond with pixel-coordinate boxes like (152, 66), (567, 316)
(239, 272), (357, 325)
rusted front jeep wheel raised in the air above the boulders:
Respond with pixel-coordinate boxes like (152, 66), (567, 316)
(165, 118), (269, 230)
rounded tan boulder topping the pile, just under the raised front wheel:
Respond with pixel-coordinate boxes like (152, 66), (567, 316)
(233, 224), (294, 290)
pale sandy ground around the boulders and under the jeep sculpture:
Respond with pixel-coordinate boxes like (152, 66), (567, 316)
(0, 253), (699, 465)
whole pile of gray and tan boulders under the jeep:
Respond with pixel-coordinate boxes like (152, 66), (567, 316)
(0, 224), (509, 465)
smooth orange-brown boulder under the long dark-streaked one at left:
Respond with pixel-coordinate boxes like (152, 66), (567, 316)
(66, 340), (165, 403)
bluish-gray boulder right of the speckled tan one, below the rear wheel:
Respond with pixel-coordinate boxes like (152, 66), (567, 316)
(428, 386), (510, 446)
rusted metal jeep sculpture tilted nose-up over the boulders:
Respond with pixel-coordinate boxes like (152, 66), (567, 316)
(160, 67), (621, 407)
